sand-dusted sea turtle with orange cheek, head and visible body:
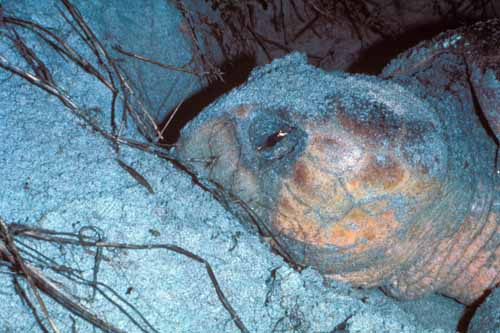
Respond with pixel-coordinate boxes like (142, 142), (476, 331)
(175, 20), (500, 304)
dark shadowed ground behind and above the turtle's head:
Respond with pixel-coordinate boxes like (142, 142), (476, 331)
(163, 0), (500, 144)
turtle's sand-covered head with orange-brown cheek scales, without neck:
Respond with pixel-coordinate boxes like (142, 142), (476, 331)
(176, 54), (492, 300)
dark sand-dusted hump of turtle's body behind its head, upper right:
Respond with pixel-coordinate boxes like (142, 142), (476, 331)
(381, 19), (500, 143)
